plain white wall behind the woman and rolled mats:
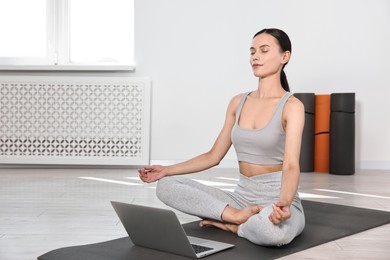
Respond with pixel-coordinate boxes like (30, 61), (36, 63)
(135, 0), (390, 168)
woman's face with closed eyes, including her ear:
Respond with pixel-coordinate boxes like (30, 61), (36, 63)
(250, 33), (290, 78)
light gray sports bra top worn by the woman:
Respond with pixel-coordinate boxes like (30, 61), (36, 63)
(232, 92), (292, 165)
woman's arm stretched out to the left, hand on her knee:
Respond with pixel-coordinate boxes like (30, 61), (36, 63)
(138, 95), (241, 182)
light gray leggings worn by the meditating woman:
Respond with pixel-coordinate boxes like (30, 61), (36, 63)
(156, 172), (305, 246)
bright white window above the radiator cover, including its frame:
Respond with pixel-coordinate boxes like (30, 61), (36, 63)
(0, 0), (134, 70)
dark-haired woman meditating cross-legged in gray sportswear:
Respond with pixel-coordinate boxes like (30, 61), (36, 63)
(139, 29), (305, 246)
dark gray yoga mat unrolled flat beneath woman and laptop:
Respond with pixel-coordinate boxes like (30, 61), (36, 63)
(38, 201), (390, 260)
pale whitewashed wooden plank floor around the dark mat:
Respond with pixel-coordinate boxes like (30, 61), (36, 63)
(0, 168), (390, 260)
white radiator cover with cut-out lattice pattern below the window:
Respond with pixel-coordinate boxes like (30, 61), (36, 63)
(0, 76), (151, 166)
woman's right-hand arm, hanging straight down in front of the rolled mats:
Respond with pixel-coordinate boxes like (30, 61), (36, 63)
(269, 97), (305, 224)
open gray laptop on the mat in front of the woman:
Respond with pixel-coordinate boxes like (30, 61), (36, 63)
(111, 201), (234, 258)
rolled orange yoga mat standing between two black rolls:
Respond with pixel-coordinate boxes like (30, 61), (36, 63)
(314, 95), (330, 172)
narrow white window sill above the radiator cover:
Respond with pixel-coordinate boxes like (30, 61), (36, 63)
(0, 64), (135, 71)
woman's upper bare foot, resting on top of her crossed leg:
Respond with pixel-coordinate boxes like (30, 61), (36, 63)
(222, 205), (263, 225)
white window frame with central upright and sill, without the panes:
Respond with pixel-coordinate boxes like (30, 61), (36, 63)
(0, 0), (135, 71)
